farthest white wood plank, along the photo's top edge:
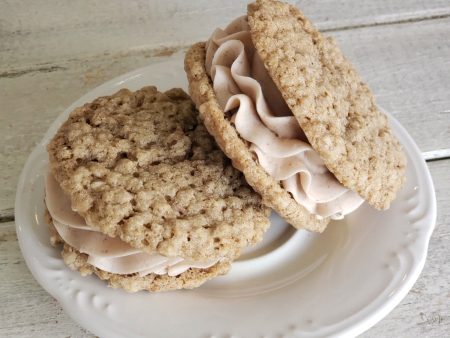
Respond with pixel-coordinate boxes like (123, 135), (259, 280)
(0, 0), (450, 69)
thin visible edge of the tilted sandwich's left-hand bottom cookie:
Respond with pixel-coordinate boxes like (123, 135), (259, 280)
(185, 43), (329, 231)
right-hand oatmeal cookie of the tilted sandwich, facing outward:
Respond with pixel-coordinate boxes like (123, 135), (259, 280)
(248, 0), (406, 209)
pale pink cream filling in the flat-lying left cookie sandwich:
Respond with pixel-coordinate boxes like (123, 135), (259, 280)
(45, 173), (218, 276)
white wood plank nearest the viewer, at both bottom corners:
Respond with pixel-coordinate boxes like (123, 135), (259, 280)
(0, 160), (450, 338)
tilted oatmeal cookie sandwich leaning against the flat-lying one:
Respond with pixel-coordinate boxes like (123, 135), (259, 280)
(185, 0), (406, 231)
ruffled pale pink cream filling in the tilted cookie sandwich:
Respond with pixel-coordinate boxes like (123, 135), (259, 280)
(205, 16), (364, 219)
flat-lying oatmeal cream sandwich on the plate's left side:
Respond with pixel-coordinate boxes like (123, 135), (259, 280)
(45, 87), (269, 291)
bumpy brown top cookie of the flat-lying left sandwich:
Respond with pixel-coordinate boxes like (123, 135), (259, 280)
(48, 87), (269, 260)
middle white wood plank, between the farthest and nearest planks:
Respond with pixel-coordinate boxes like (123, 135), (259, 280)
(0, 18), (450, 210)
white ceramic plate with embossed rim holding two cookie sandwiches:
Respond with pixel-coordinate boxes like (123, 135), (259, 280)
(15, 55), (436, 337)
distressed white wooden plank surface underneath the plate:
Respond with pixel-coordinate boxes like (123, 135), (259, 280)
(0, 0), (450, 337)
